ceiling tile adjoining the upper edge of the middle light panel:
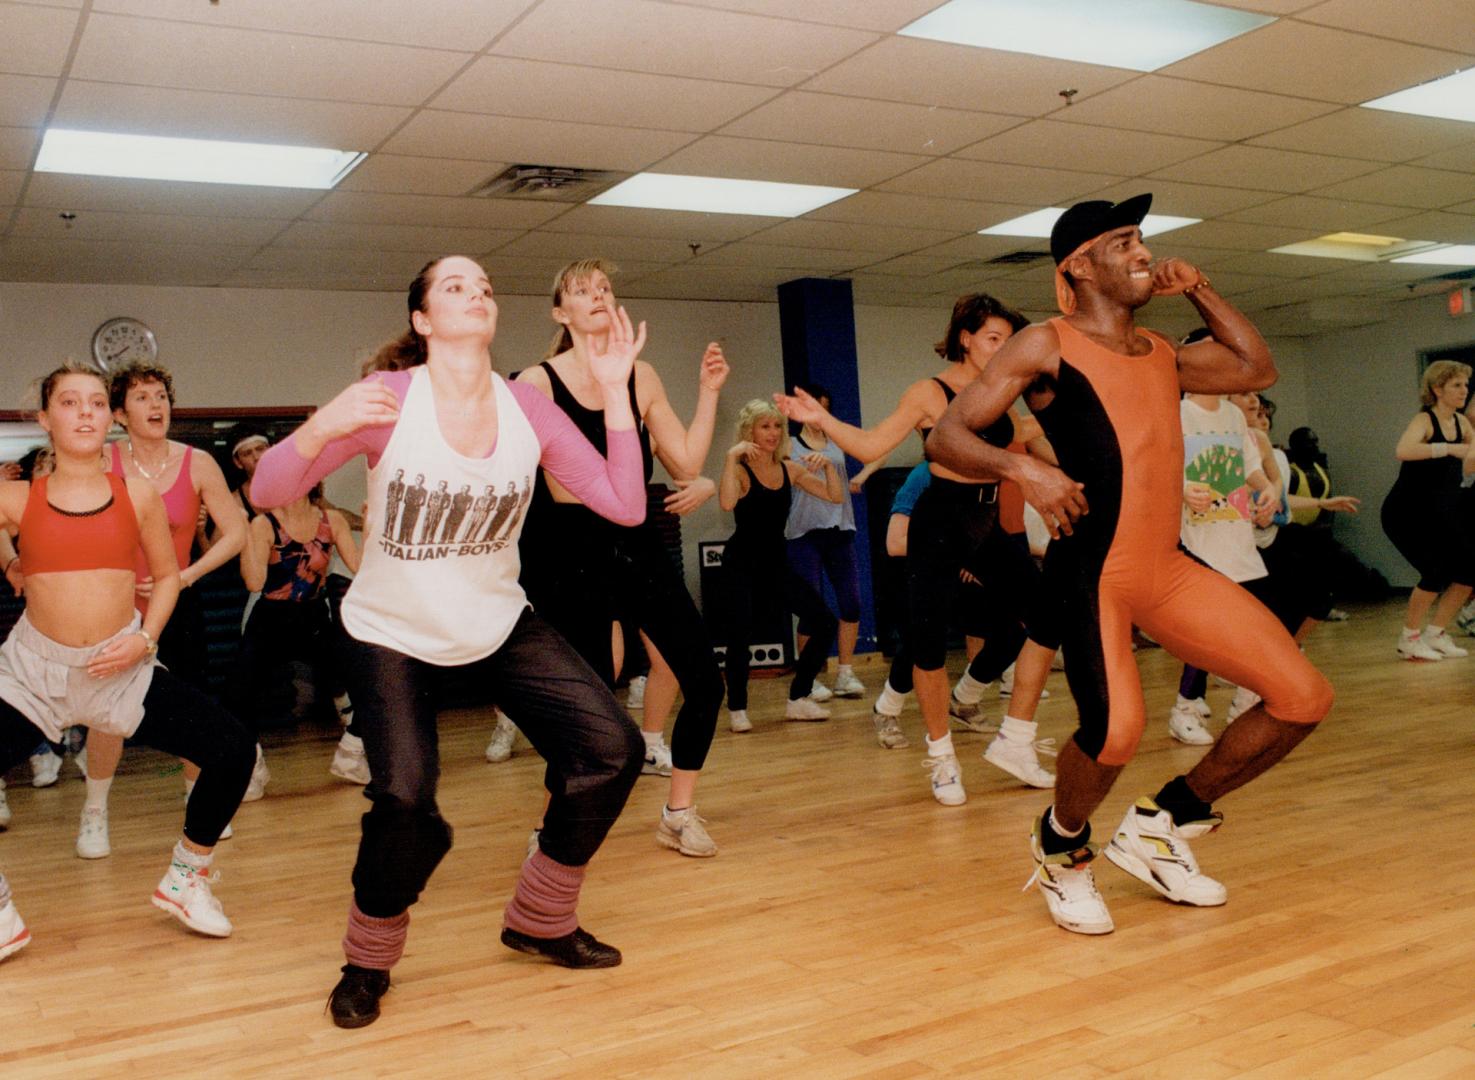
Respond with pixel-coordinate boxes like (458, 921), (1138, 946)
(656, 136), (931, 187)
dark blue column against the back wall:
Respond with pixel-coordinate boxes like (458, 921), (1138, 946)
(779, 277), (876, 652)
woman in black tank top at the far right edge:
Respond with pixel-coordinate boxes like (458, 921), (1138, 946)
(1382, 360), (1475, 660)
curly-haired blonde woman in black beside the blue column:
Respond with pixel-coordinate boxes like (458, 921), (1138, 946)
(717, 398), (844, 732)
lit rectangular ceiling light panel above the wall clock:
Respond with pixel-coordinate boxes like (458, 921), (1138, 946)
(35, 127), (364, 190)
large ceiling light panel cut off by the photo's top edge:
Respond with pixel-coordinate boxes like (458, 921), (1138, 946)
(897, 0), (1274, 71)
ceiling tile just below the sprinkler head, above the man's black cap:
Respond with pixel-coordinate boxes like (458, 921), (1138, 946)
(954, 119), (1223, 176)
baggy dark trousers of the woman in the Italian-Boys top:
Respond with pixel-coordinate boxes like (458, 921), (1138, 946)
(344, 608), (645, 919)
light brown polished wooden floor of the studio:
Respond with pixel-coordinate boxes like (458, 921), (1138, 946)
(0, 603), (1475, 1080)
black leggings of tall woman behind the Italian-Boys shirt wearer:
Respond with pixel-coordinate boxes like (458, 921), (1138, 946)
(525, 505), (723, 770)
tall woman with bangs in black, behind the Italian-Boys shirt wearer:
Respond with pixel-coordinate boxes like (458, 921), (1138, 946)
(516, 260), (727, 857)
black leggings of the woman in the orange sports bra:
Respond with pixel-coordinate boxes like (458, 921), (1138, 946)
(0, 667), (257, 847)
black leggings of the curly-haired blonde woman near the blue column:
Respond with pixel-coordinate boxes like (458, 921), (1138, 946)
(723, 543), (839, 710)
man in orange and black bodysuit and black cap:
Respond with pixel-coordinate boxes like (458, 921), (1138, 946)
(926, 195), (1332, 934)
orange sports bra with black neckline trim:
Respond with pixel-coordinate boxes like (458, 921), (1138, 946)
(21, 472), (139, 575)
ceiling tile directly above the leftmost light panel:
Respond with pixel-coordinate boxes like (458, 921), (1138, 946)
(53, 78), (410, 150)
